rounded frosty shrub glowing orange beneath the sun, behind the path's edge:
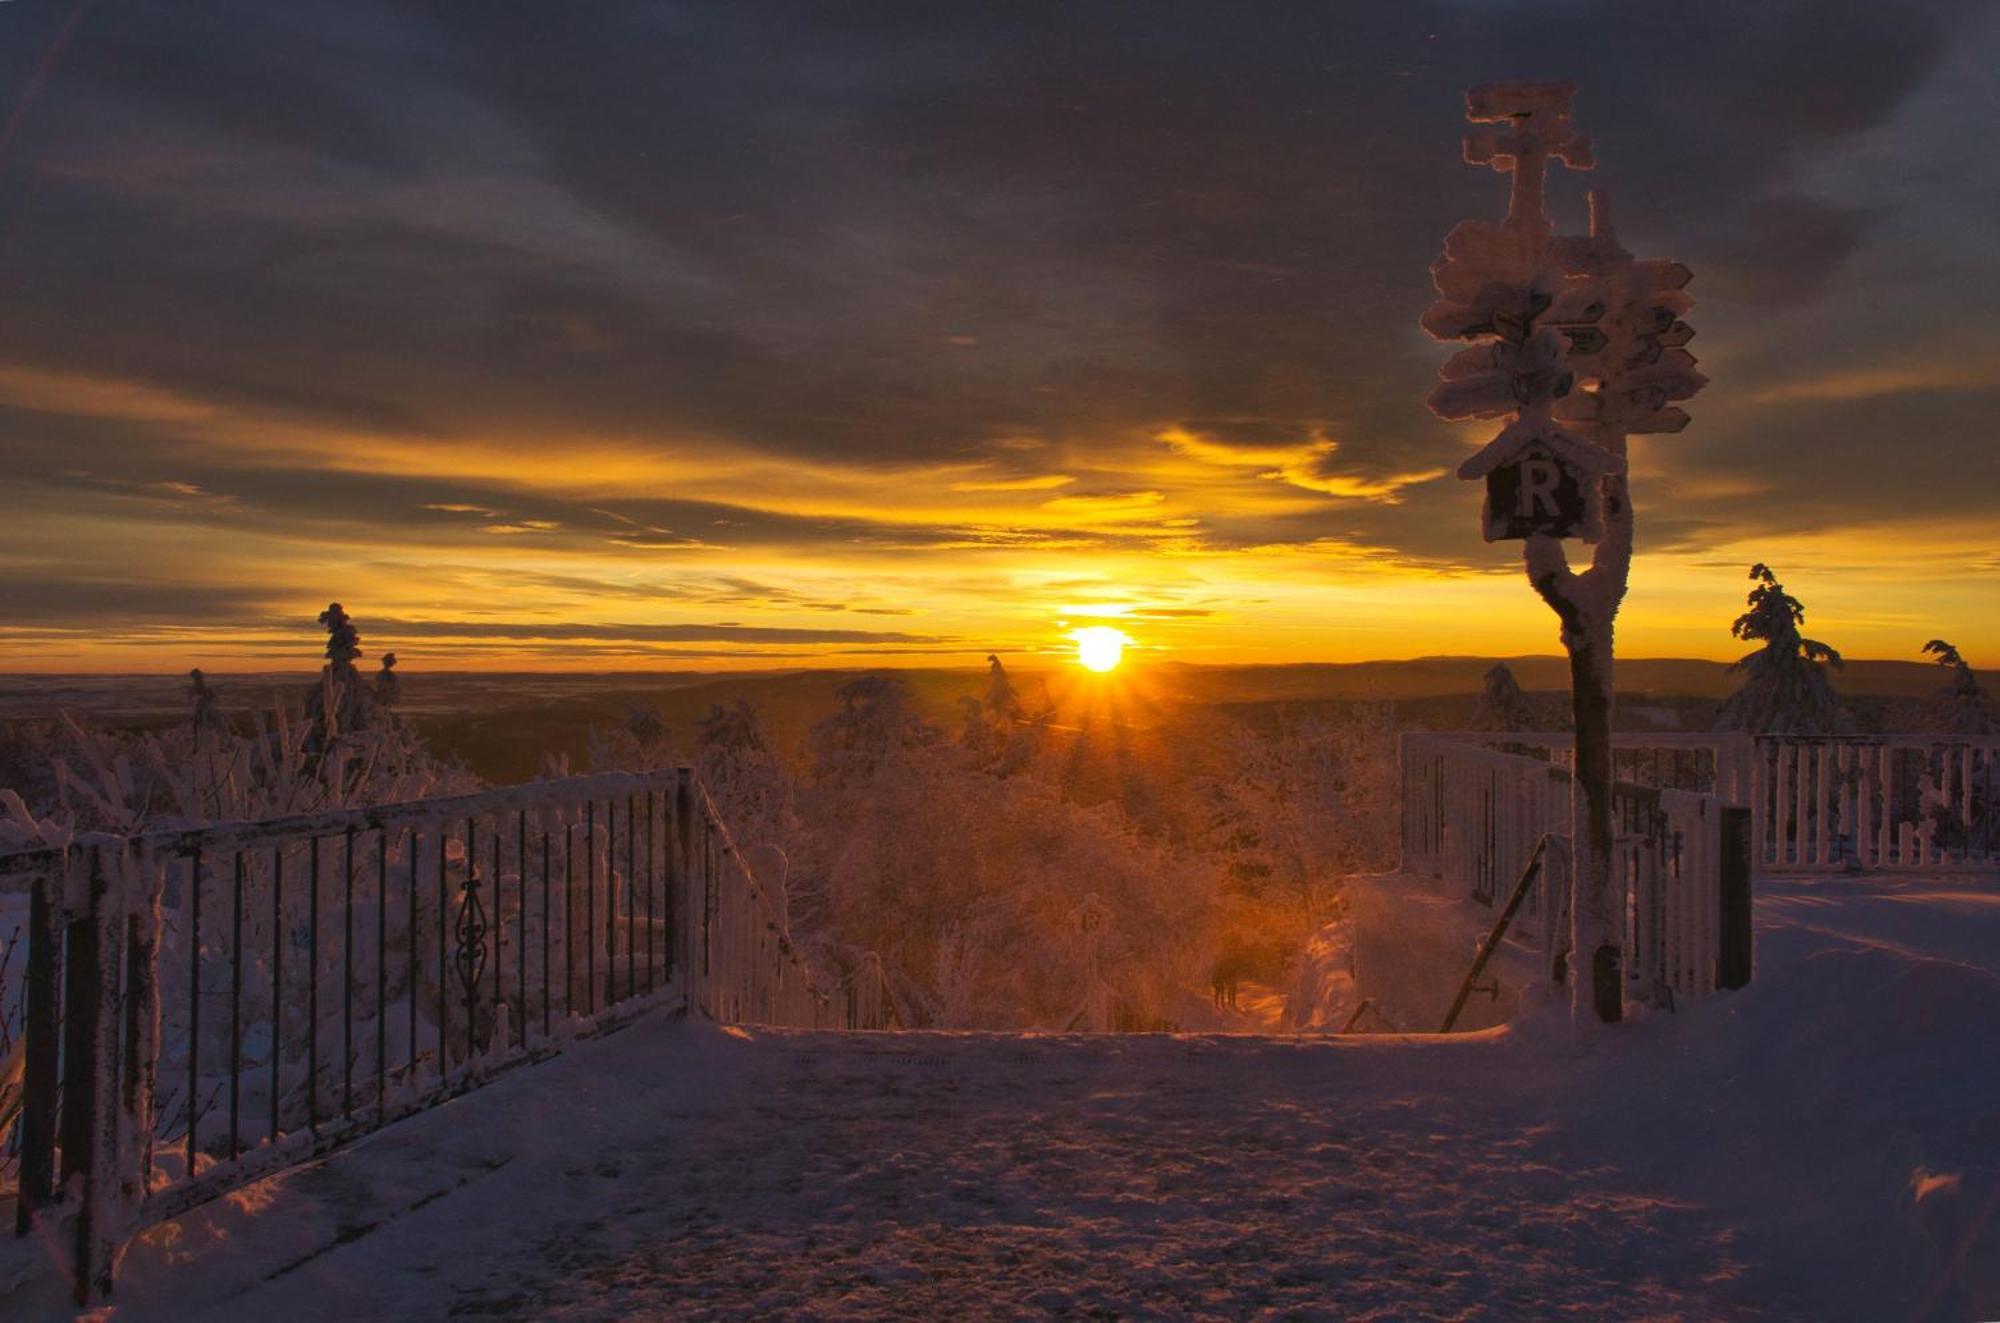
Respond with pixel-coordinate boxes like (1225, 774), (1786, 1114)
(794, 743), (1220, 1029)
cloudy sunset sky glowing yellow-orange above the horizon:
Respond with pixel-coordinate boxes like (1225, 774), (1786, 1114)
(0, 0), (2000, 671)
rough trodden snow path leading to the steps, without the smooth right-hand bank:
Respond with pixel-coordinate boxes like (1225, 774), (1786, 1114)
(120, 1023), (1768, 1319)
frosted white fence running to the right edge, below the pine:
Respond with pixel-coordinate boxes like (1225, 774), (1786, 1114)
(1452, 731), (2000, 873)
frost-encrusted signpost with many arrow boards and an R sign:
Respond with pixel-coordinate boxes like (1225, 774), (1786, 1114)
(1424, 82), (1704, 1021)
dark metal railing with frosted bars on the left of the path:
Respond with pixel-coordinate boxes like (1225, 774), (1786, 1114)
(0, 767), (876, 1297)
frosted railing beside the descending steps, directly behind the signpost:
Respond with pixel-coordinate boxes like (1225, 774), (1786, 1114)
(1402, 733), (1750, 1003)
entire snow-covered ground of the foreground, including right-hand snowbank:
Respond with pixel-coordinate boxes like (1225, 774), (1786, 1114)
(23, 881), (2000, 1321)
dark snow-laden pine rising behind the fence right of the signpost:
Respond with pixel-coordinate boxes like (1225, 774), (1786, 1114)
(1716, 562), (1842, 735)
